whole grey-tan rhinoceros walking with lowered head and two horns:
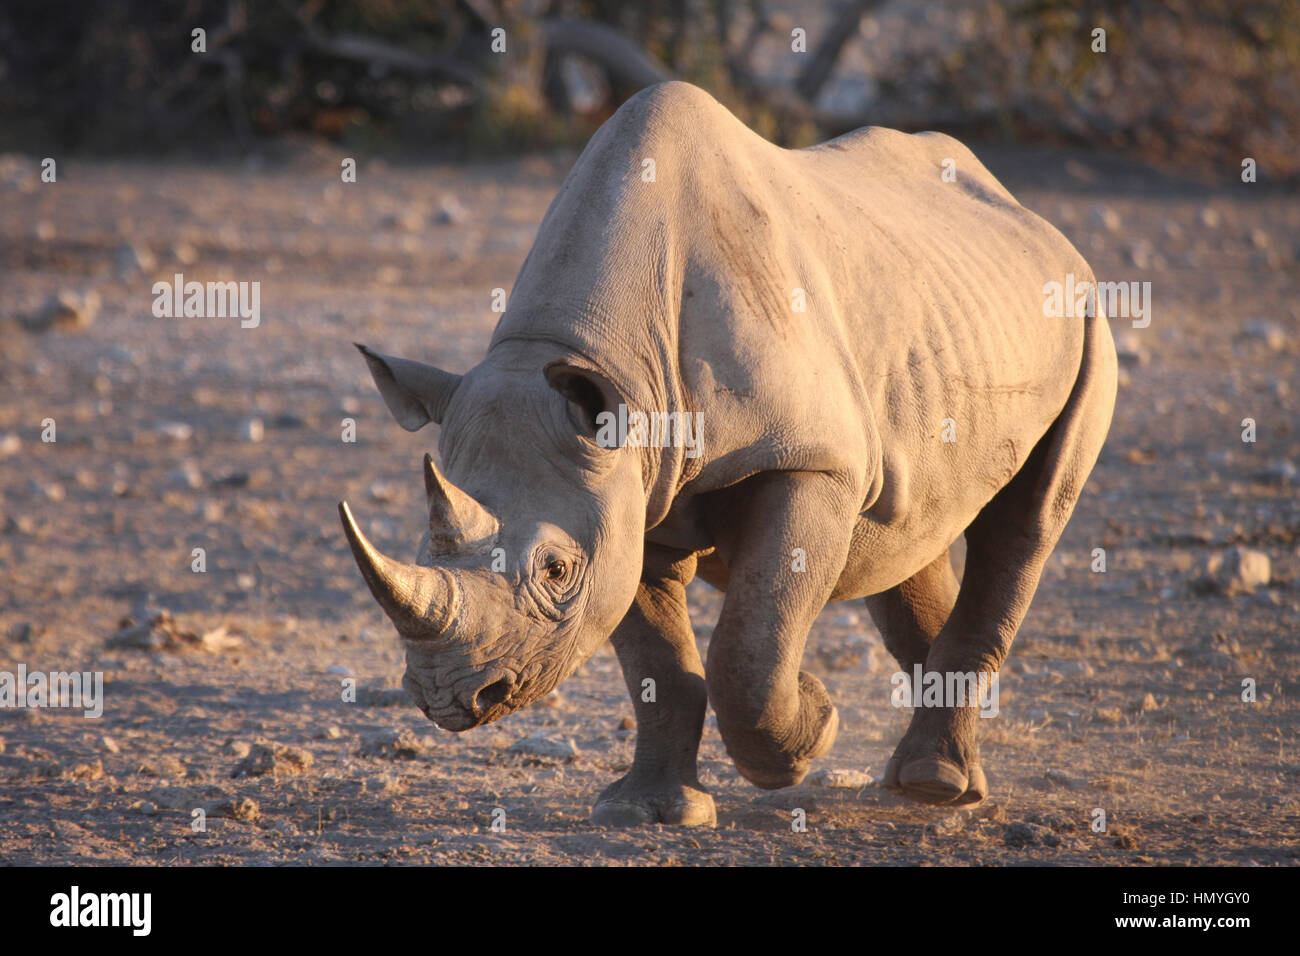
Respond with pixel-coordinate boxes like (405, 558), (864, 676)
(339, 82), (1117, 825)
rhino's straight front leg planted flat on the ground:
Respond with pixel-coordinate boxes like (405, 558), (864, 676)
(592, 544), (718, 826)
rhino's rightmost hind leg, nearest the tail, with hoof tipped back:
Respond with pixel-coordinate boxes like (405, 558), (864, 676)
(885, 310), (1115, 804)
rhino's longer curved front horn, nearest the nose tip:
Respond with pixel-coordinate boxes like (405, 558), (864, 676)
(338, 501), (460, 640)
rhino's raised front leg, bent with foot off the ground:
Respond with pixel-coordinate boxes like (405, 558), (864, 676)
(709, 472), (857, 790)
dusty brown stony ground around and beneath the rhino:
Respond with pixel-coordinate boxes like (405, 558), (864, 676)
(0, 141), (1300, 865)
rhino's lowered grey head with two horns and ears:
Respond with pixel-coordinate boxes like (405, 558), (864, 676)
(339, 346), (645, 731)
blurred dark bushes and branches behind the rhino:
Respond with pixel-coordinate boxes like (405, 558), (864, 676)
(0, 0), (1300, 179)
